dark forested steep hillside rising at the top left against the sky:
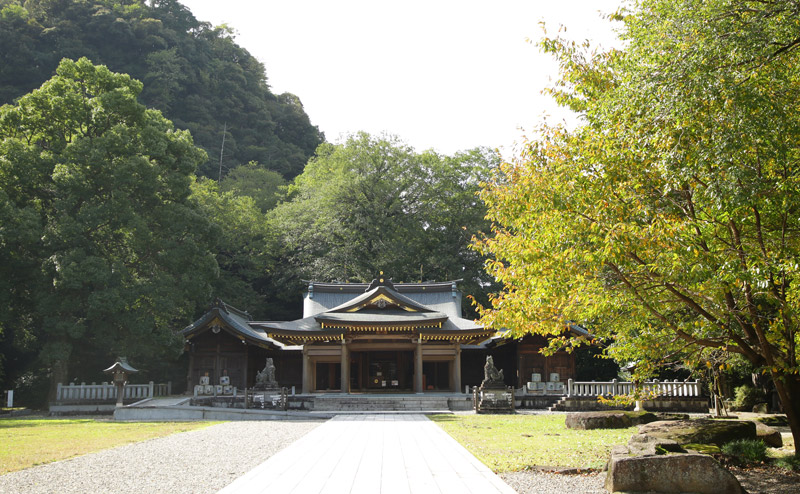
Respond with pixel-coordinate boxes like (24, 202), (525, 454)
(0, 0), (323, 179)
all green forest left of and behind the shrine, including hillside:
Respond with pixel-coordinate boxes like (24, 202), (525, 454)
(0, 0), (498, 406)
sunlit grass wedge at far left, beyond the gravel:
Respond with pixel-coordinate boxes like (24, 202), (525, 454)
(0, 417), (215, 475)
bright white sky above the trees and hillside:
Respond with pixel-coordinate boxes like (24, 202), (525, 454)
(181, 0), (620, 155)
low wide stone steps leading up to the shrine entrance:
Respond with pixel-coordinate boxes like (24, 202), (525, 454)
(304, 393), (472, 413)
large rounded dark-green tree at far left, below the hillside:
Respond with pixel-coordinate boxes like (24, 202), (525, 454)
(0, 59), (217, 396)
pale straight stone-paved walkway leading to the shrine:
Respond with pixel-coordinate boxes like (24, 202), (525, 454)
(218, 414), (514, 494)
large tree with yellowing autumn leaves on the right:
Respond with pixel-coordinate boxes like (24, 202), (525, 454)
(477, 0), (800, 443)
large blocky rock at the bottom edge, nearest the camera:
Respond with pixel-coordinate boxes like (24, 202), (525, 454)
(605, 453), (744, 494)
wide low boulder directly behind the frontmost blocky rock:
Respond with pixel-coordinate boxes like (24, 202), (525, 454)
(639, 419), (756, 446)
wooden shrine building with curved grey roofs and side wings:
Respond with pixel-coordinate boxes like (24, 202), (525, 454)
(182, 278), (582, 394)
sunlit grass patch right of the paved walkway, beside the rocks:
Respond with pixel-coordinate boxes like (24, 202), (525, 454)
(430, 414), (636, 473)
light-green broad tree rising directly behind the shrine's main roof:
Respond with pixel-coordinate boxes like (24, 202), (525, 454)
(270, 133), (497, 316)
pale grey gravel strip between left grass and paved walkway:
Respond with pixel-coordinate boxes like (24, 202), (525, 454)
(0, 421), (321, 494)
